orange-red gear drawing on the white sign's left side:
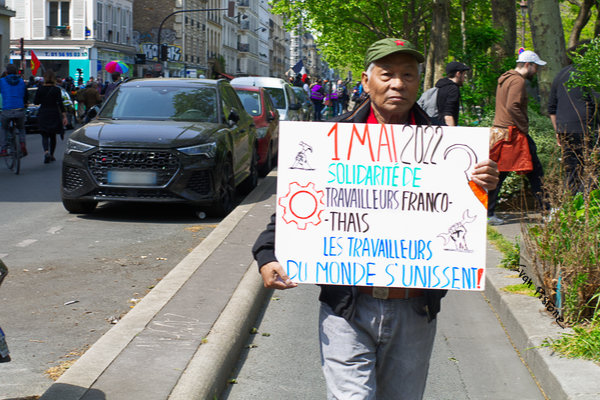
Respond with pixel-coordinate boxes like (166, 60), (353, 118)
(279, 182), (325, 230)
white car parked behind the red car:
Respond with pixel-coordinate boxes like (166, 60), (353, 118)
(231, 76), (303, 121)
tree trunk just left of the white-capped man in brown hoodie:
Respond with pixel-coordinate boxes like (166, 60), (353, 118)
(491, 0), (517, 64)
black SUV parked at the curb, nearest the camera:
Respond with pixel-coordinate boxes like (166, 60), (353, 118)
(61, 78), (258, 216)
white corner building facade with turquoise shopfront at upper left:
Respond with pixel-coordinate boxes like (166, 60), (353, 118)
(6, 0), (135, 81)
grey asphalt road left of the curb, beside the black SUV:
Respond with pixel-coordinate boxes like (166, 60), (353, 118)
(0, 130), (226, 399)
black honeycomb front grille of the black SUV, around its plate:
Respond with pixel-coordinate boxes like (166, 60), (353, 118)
(88, 150), (179, 186)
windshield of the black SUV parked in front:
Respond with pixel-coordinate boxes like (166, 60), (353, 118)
(99, 86), (217, 123)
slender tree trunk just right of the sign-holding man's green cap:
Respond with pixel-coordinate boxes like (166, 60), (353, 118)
(423, 0), (450, 90)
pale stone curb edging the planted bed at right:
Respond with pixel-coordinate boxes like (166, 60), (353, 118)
(485, 239), (600, 400)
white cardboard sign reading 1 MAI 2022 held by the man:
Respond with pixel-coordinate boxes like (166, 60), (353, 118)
(275, 121), (489, 290)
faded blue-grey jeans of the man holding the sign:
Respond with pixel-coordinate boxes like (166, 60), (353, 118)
(319, 294), (436, 400)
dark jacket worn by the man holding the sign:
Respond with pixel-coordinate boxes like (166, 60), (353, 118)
(252, 98), (447, 320)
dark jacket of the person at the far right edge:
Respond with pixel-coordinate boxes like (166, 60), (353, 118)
(548, 65), (598, 136)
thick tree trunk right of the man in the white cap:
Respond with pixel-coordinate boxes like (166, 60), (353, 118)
(528, 0), (568, 113)
